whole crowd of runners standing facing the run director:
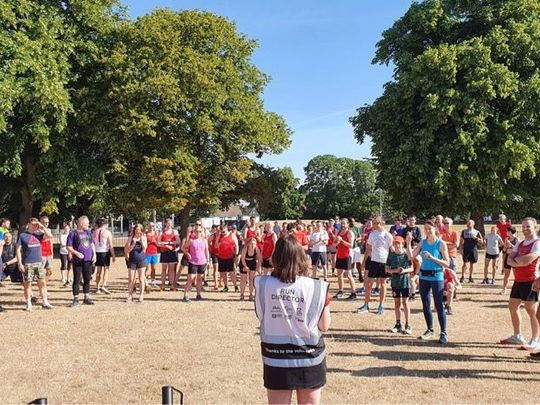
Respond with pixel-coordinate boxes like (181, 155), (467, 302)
(0, 211), (540, 357)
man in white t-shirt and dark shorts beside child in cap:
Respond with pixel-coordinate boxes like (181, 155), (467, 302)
(358, 217), (393, 315)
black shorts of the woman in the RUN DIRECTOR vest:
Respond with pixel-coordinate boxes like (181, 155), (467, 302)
(263, 359), (326, 390)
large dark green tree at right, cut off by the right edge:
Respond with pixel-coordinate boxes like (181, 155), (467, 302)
(351, 0), (540, 229)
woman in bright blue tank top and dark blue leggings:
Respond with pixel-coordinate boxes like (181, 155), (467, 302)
(406, 221), (450, 344)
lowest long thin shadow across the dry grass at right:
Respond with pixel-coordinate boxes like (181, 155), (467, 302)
(327, 366), (540, 382)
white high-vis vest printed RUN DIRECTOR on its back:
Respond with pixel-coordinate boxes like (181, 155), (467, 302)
(255, 276), (328, 368)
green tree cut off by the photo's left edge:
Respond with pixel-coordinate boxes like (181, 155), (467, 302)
(0, 0), (121, 223)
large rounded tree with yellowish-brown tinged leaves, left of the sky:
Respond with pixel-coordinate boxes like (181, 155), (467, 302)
(96, 9), (290, 226)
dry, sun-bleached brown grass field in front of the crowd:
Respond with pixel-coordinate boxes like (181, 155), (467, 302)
(0, 254), (540, 403)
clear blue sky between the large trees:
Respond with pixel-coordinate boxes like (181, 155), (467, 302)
(122, 0), (411, 179)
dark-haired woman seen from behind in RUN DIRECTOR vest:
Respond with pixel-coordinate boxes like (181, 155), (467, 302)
(255, 235), (330, 404)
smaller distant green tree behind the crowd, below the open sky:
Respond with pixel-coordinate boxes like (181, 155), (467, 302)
(301, 155), (388, 220)
